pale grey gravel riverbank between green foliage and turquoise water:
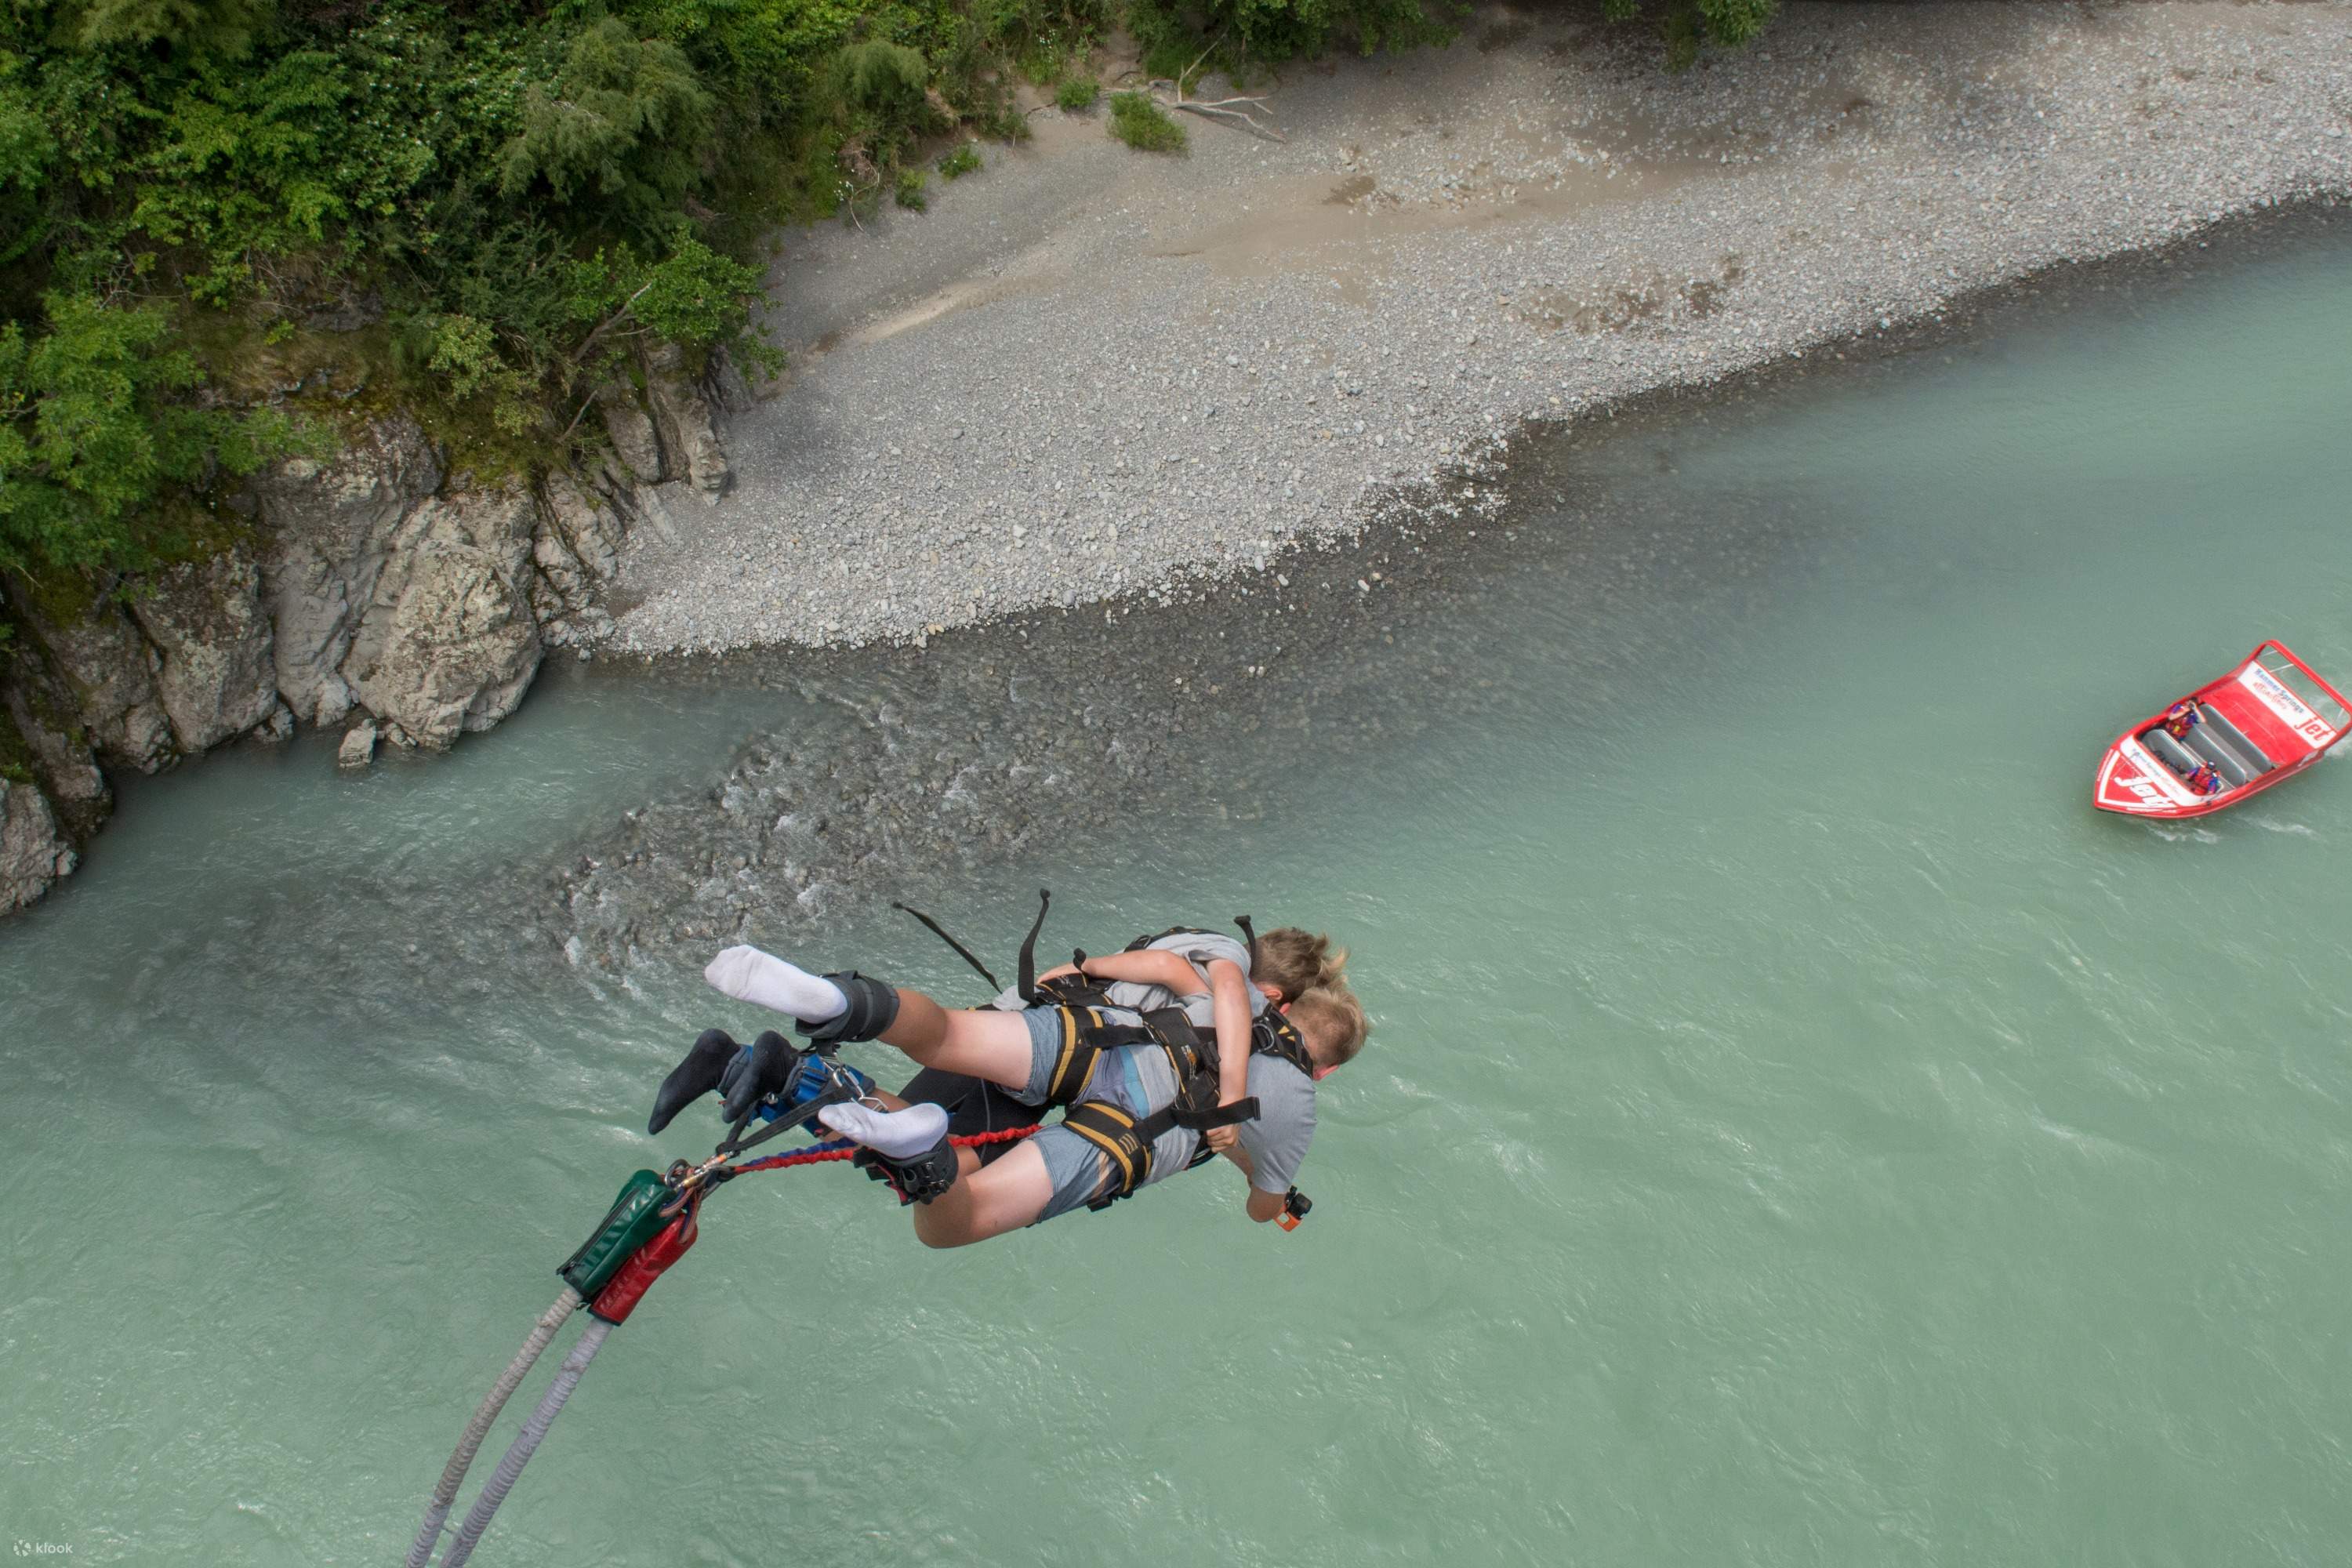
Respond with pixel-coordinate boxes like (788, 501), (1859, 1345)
(607, 2), (2352, 654)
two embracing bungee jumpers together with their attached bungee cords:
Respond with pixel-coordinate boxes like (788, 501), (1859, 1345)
(405, 893), (1369, 1568)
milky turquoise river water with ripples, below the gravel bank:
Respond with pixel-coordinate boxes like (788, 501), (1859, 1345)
(0, 223), (2352, 1568)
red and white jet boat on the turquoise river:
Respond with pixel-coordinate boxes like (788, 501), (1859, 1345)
(2091, 642), (2352, 818)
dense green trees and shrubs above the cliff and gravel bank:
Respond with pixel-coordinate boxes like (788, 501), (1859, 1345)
(0, 0), (1771, 606)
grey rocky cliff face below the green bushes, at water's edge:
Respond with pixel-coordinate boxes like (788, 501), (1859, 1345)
(0, 343), (729, 912)
